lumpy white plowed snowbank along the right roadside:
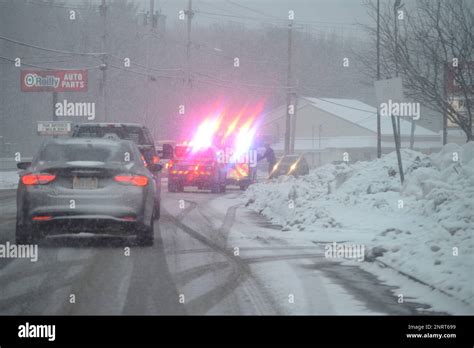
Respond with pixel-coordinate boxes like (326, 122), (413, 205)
(243, 142), (474, 305)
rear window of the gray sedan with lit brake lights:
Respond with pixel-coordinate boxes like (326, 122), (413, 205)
(37, 144), (134, 163)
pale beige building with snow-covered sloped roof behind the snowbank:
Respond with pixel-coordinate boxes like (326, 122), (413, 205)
(261, 97), (442, 166)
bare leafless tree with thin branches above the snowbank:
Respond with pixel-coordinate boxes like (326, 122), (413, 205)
(359, 0), (474, 141)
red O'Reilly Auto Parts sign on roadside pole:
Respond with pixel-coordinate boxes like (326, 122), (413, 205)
(21, 70), (87, 92)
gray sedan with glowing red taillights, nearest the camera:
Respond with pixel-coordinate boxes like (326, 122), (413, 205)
(16, 138), (159, 245)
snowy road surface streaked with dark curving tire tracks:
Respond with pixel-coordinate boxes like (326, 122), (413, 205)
(0, 189), (462, 315)
